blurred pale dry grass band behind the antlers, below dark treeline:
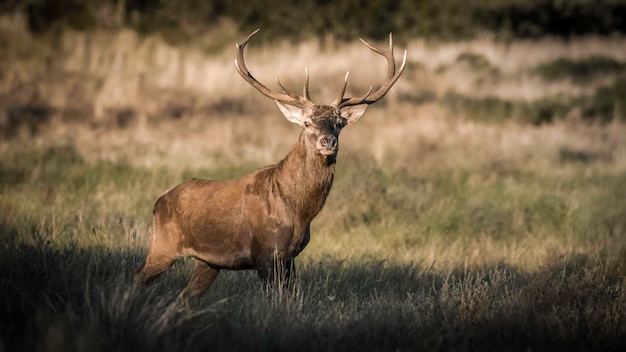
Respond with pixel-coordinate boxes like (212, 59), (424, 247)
(0, 26), (626, 123)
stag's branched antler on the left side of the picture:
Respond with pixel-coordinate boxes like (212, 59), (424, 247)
(235, 29), (313, 108)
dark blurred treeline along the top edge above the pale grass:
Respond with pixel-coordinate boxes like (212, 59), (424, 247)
(0, 0), (626, 42)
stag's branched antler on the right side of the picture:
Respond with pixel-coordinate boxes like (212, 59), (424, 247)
(331, 33), (407, 109)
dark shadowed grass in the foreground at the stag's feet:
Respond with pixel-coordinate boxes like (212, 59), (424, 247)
(0, 244), (626, 351)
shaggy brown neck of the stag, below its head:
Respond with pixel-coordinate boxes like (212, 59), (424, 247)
(275, 132), (335, 223)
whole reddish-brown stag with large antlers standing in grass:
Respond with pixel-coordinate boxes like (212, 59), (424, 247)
(135, 30), (406, 297)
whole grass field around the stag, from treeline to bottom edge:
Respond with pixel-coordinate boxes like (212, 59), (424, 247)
(0, 25), (626, 351)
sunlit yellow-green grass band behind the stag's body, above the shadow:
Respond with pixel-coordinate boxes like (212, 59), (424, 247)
(0, 105), (625, 269)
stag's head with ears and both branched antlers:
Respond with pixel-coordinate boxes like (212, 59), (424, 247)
(235, 29), (407, 157)
